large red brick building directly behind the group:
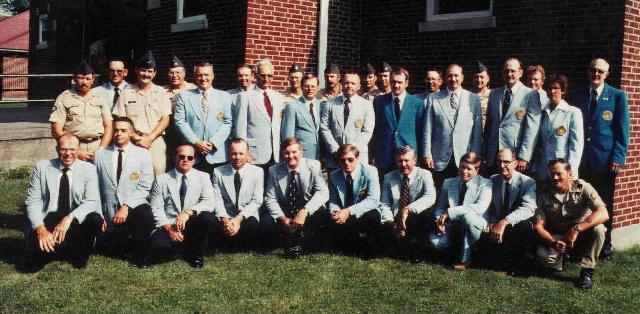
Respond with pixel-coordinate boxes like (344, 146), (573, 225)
(31, 0), (640, 247)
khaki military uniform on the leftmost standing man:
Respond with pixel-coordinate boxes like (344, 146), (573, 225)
(49, 89), (112, 152)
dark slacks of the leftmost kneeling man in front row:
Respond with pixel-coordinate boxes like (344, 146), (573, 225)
(25, 212), (102, 263)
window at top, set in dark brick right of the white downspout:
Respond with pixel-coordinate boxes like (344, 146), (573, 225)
(420, 0), (496, 31)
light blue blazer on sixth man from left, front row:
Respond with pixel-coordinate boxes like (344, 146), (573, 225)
(329, 164), (380, 218)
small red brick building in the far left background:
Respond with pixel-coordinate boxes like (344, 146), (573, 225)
(0, 11), (29, 100)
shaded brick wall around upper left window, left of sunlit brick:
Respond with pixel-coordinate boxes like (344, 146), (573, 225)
(147, 0), (247, 89)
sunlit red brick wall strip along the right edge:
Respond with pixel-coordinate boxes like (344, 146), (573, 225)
(613, 0), (640, 228)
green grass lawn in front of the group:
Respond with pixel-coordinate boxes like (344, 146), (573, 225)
(0, 169), (640, 313)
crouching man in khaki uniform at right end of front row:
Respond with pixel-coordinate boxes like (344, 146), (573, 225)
(534, 159), (609, 289)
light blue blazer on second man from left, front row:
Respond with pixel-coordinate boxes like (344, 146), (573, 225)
(94, 143), (154, 224)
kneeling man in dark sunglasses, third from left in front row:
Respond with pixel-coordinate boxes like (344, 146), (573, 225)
(145, 145), (217, 268)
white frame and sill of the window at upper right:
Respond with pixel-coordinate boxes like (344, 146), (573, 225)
(420, 0), (496, 32)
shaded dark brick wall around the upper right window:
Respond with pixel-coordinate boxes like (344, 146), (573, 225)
(361, 0), (625, 91)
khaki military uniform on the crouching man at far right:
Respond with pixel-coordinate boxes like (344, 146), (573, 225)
(536, 179), (607, 269)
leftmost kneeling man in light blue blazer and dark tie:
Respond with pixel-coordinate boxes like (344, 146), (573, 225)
(25, 133), (102, 271)
